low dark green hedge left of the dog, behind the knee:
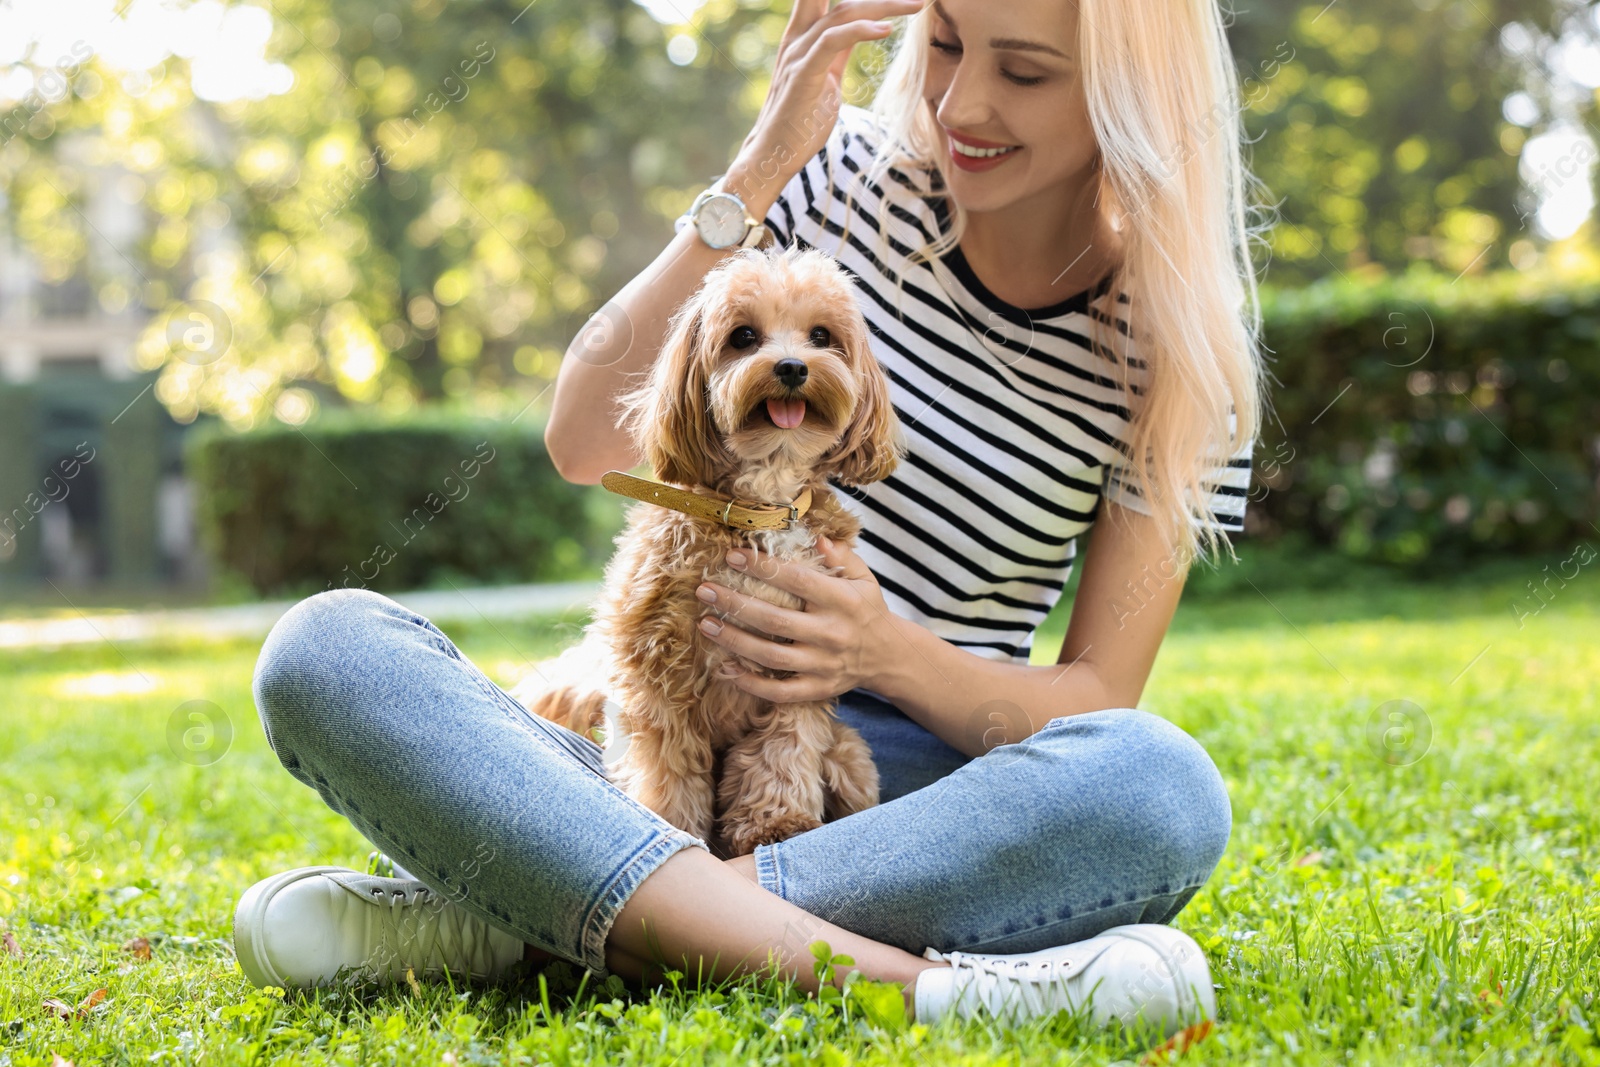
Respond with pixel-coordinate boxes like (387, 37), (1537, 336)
(189, 413), (622, 593)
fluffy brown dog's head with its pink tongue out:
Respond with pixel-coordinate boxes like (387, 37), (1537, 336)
(630, 250), (915, 491)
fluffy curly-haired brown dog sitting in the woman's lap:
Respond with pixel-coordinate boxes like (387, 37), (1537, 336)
(518, 250), (901, 856)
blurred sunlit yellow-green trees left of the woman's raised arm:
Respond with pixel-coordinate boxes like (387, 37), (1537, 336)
(0, 0), (838, 424)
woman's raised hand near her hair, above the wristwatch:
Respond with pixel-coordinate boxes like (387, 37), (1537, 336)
(728, 0), (923, 218)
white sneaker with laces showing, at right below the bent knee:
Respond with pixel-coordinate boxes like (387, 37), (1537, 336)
(912, 925), (1216, 1037)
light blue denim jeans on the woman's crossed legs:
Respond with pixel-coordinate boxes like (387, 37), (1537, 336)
(254, 589), (1232, 974)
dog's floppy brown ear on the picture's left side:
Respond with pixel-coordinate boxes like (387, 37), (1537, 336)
(621, 290), (723, 485)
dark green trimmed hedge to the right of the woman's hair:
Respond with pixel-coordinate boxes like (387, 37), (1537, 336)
(1246, 263), (1600, 573)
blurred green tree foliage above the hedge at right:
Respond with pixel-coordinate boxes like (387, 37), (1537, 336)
(1230, 0), (1594, 285)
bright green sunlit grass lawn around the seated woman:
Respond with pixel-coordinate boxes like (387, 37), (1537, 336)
(0, 560), (1600, 1067)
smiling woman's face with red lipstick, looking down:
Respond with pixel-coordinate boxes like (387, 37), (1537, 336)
(923, 0), (1096, 213)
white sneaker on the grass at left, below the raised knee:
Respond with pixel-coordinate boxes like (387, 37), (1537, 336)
(234, 867), (523, 989)
